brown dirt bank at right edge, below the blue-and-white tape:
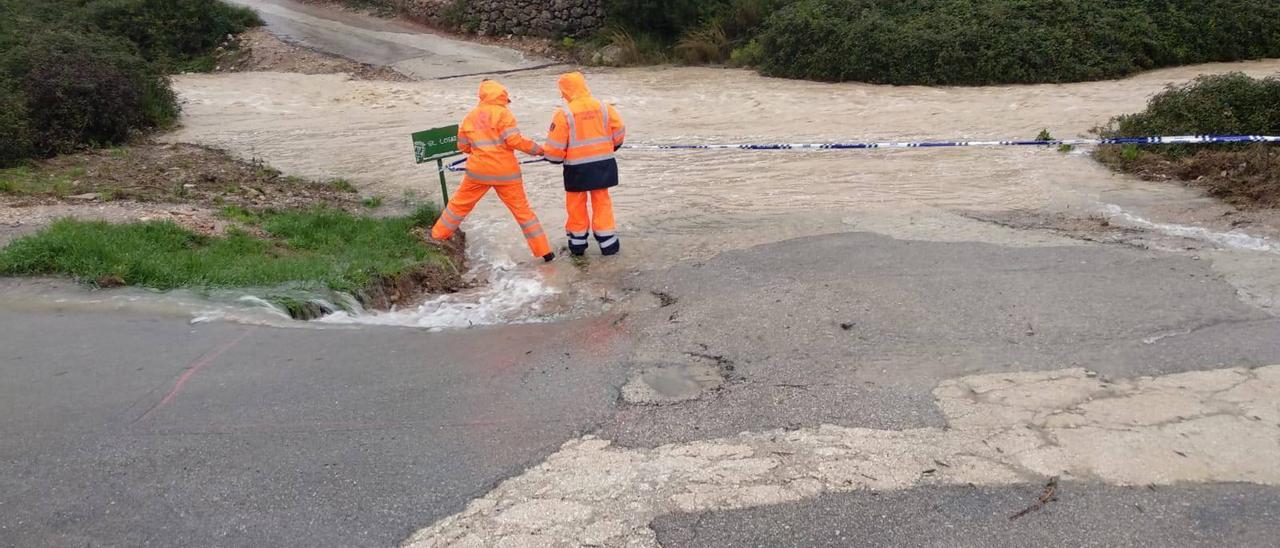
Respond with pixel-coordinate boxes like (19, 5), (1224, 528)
(1097, 145), (1280, 209)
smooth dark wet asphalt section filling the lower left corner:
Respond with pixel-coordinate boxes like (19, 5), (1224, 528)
(0, 310), (626, 547)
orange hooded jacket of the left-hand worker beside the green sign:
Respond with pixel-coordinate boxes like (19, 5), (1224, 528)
(458, 81), (543, 186)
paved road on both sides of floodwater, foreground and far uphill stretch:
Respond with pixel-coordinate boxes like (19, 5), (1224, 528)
(0, 0), (1280, 547)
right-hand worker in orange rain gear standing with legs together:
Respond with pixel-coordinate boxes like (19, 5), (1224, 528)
(543, 72), (626, 255)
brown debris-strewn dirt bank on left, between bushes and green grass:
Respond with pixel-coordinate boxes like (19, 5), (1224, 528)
(0, 143), (361, 239)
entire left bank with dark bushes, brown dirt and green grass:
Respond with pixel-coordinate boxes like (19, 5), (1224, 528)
(0, 0), (462, 318)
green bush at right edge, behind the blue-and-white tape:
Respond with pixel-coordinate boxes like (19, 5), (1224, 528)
(1098, 73), (1280, 156)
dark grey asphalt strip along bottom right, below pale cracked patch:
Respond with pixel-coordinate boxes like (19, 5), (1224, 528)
(654, 483), (1280, 548)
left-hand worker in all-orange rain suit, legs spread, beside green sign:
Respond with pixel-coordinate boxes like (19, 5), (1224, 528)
(431, 79), (556, 262)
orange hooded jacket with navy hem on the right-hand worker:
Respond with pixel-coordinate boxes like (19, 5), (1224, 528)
(544, 72), (627, 192)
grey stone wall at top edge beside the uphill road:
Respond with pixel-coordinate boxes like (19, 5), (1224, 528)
(378, 0), (604, 37)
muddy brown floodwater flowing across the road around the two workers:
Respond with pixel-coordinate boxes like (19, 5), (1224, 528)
(157, 60), (1280, 326)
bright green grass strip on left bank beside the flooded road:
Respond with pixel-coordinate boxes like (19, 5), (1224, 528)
(0, 206), (447, 292)
